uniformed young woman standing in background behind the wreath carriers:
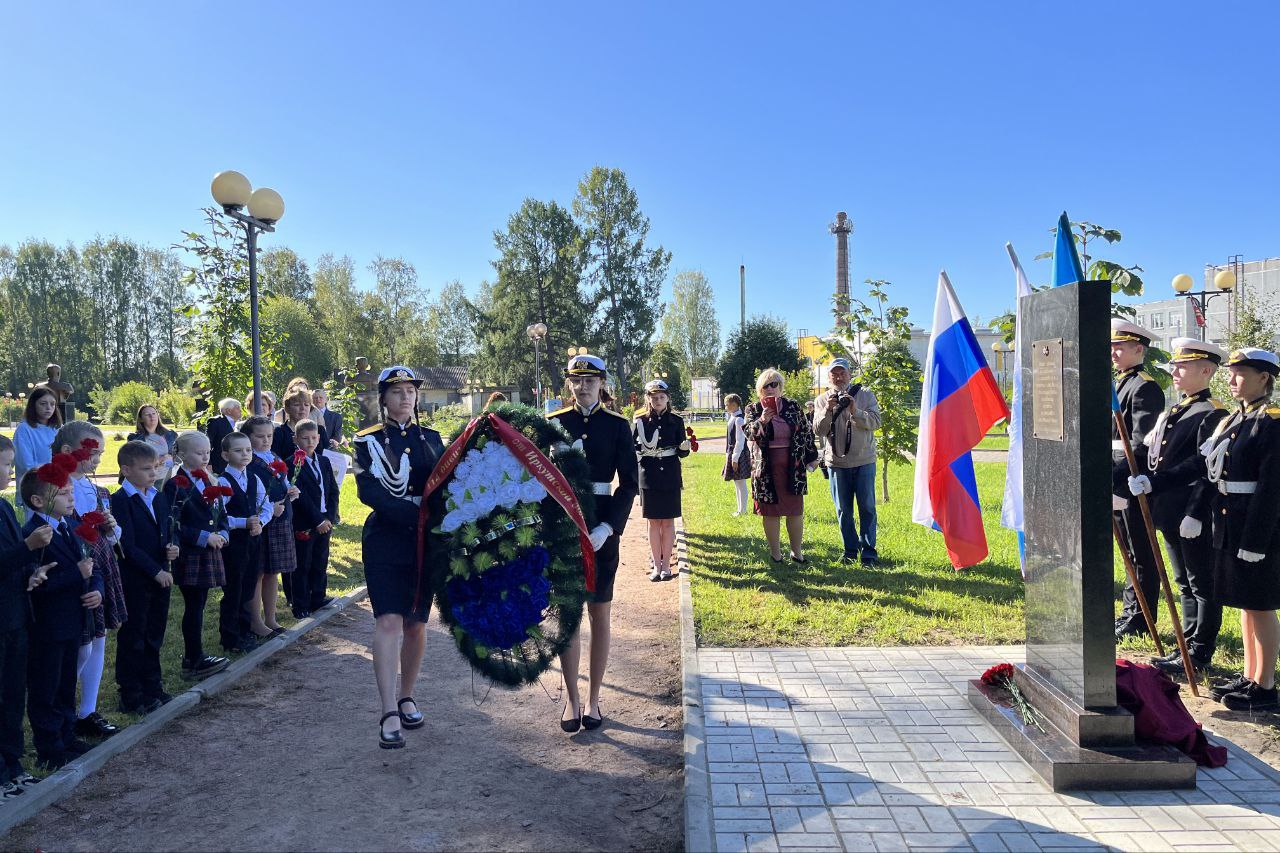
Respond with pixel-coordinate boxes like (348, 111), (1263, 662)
(631, 379), (689, 580)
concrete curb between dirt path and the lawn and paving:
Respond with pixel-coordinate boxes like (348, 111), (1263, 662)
(676, 519), (716, 853)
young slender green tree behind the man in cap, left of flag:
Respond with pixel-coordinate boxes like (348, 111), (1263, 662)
(824, 279), (923, 503)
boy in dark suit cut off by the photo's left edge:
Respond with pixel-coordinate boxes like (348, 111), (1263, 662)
(0, 435), (54, 799)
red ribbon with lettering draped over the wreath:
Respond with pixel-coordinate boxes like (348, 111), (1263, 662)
(413, 412), (595, 610)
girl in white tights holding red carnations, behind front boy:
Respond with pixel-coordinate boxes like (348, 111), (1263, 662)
(52, 420), (129, 739)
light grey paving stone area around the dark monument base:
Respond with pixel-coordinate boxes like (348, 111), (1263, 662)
(694, 647), (1280, 853)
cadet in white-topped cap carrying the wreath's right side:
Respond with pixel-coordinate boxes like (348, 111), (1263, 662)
(549, 355), (640, 731)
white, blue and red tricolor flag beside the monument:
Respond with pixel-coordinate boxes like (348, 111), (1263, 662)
(911, 272), (1009, 569)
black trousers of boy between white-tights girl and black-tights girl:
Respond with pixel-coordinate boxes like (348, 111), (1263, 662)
(115, 571), (169, 704)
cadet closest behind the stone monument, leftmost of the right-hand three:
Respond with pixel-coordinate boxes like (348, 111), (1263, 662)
(1111, 319), (1165, 639)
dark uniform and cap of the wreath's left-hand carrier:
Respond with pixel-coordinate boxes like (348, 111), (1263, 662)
(355, 366), (444, 621)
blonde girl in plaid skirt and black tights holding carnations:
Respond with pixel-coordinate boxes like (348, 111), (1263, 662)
(164, 430), (230, 679)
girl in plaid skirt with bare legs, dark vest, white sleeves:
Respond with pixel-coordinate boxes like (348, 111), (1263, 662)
(241, 415), (298, 639)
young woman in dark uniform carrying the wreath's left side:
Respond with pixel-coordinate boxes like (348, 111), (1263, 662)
(356, 366), (444, 749)
